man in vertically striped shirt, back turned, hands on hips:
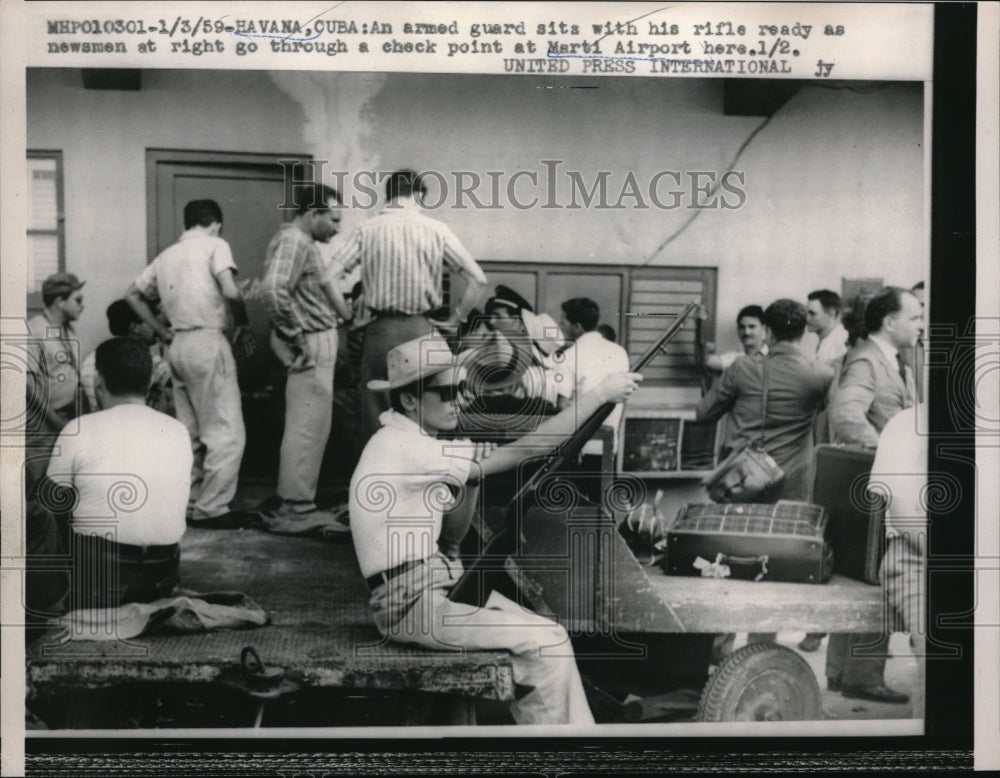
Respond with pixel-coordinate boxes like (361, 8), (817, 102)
(334, 170), (486, 442)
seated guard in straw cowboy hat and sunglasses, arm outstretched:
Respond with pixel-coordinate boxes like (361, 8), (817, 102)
(350, 328), (641, 724)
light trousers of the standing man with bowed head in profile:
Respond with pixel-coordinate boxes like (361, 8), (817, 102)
(277, 329), (337, 508)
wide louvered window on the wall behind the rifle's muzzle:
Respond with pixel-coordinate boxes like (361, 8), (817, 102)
(464, 261), (717, 386)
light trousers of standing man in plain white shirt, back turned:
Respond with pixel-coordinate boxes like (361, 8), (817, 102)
(169, 329), (246, 519)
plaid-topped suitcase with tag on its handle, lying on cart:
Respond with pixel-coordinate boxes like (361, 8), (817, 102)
(663, 500), (833, 583)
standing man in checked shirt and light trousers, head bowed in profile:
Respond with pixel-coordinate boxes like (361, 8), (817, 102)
(262, 183), (350, 530)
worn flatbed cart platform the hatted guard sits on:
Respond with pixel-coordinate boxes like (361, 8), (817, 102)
(27, 529), (514, 700)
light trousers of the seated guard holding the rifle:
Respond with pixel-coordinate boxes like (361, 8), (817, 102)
(370, 554), (594, 725)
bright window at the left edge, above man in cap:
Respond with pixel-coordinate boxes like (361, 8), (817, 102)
(27, 151), (66, 309)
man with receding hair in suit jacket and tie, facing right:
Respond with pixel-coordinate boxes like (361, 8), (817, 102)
(826, 287), (924, 703)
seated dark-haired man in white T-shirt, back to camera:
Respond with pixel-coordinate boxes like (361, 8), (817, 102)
(42, 338), (192, 609)
